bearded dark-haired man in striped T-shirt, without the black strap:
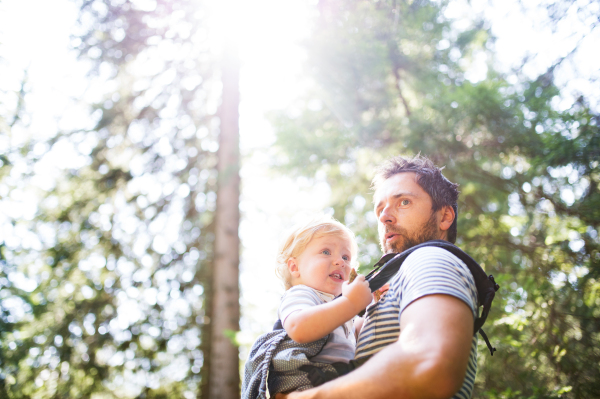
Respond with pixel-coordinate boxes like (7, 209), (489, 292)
(277, 156), (477, 399)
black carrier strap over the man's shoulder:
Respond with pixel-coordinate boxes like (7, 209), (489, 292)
(366, 240), (500, 356)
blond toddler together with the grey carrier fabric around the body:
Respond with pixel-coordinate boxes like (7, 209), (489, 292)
(242, 216), (372, 398)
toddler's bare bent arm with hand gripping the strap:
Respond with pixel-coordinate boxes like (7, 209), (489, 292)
(283, 276), (372, 343)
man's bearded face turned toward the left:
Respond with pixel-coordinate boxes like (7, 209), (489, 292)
(373, 172), (444, 254)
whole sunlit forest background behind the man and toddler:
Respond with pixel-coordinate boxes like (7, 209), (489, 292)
(0, 0), (600, 398)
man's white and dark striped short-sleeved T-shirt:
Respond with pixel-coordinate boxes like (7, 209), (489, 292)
(356, 247), (477, 399)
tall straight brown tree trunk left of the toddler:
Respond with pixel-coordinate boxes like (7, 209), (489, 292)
(208, 24), (240, 399)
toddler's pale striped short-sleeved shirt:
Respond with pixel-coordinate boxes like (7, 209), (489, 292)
(278, 285), (356, 364)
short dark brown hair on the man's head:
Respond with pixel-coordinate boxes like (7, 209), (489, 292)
(372, 154), (459, 243)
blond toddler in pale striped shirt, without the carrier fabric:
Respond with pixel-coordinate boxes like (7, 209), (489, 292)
(277, 216), (372, 363)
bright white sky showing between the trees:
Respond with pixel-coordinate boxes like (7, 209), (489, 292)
(0, 0), (600, 356)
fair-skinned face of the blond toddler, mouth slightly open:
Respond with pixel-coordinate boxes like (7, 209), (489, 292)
(288, 235), (351, 296)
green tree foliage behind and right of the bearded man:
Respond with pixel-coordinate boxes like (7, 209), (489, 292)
(272, 0), (600, 398)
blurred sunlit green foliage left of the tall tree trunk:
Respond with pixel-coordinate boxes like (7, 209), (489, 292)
(0, 0), (219, 398)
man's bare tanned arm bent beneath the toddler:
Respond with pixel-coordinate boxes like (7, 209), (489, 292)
(276, 294), (473, 399)
